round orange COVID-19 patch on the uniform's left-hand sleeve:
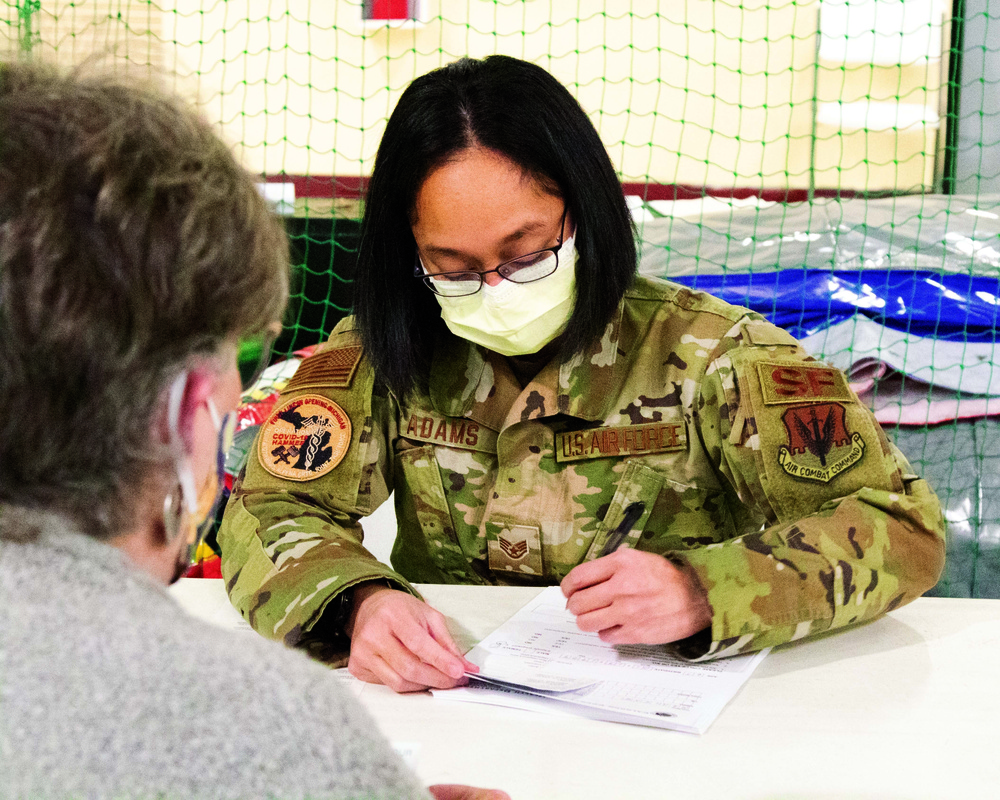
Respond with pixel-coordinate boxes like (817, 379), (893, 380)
(257, 394), (351, 481)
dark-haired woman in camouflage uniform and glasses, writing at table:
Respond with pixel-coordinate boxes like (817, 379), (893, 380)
(220, 56), (944, 691)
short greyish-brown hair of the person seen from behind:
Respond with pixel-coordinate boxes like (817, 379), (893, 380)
(0, 62), (289, 539)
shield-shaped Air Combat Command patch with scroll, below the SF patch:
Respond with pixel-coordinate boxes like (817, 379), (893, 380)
(778, 403), (865, 483)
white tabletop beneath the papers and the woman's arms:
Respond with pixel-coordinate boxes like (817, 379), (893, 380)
(172, 580), (1000, 800)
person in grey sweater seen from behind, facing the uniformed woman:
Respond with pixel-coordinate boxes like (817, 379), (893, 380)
(0, 62), (506, 798)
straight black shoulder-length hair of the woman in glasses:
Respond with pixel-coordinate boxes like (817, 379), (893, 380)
(354, 56), (637, 398)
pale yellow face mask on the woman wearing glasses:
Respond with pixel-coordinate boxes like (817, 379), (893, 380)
(425, 236), (578, 356)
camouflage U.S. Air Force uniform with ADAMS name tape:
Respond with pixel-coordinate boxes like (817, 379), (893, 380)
(219, 278), (944, 658)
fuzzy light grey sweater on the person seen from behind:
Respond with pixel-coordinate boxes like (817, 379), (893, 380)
(0, 511), (429, 800)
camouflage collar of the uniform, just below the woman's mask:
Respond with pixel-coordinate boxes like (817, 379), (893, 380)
(429, 300), (648, 431)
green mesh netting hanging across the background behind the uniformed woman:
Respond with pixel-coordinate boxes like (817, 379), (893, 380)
(0, 0), (1000, 596)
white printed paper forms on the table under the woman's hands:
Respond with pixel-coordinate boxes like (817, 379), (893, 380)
(434, 586), (768, 733)
